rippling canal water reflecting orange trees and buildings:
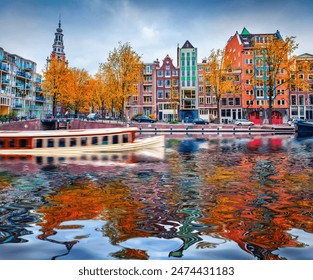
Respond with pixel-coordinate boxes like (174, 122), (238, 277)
(0, 135), (313, 260)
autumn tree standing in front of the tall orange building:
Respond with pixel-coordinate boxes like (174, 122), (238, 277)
(253, 35), (298, 124)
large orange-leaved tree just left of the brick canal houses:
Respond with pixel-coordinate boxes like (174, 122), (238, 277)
(98, 43), (143, 116)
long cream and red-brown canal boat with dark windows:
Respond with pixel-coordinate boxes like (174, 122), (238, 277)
(0, 127), (165, 155)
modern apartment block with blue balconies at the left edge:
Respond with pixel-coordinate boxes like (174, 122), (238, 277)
(0, 47), (48, 117)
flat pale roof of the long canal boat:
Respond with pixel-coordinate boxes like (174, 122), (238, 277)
(0, 127), (138, 138)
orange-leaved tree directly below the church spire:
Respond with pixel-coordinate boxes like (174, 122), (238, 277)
(42, 57), (70, 114)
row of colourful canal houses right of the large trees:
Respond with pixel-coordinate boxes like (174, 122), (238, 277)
(126, 28), (313, 124)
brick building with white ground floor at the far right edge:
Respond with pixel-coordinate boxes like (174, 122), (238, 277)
(290, 53), (313, 120)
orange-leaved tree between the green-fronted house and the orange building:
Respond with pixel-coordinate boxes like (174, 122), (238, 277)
(203, 49), (236, 123)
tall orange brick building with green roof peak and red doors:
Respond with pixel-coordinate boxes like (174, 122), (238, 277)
(226, 28), (289, 124)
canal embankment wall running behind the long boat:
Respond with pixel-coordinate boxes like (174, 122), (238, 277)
(0, 119), (296, 136)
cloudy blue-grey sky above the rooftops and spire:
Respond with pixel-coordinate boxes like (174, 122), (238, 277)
(0, 0), (313, 74)
